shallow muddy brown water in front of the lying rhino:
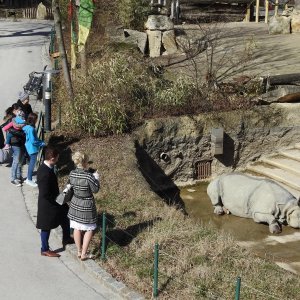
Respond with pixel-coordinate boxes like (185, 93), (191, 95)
(180, 183), (300, 274)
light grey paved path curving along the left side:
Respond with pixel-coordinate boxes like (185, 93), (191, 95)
(0, 21), (121, 300)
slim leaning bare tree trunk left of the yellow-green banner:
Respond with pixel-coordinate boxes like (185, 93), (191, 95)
(52, 0), (74, 101)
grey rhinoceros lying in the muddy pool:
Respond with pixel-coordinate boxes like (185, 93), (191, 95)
(207, 172), (300, 233)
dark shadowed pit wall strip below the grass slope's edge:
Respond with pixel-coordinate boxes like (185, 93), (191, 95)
(135, 142), (187, 214)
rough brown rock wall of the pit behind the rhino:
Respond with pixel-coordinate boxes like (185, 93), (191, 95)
(134, 103), (300, 190)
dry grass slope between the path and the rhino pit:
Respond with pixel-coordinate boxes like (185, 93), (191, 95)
(52, 136), (300, 299)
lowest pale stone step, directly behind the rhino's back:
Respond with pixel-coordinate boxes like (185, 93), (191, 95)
(246, 162), (300, 191)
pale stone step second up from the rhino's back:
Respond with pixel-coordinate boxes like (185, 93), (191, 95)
(260, 154), (300, 176)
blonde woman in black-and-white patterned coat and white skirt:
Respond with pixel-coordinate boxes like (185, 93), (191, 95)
(68, 152), (100, 260)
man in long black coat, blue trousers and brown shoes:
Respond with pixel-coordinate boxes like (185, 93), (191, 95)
(36, 146), (74, 257)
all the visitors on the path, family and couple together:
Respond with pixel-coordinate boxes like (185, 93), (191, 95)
(1, 93), (100, 260)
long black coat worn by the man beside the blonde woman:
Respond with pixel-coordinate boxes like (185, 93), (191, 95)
(36, 163), (69, 230)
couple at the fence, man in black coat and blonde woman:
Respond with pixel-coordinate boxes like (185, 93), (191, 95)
(36, 145), (100, 260)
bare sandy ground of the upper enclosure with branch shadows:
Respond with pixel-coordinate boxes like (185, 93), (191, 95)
(162, 22), (300, 77)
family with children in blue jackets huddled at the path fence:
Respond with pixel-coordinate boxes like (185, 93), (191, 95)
(1, 92), (45, 187)
